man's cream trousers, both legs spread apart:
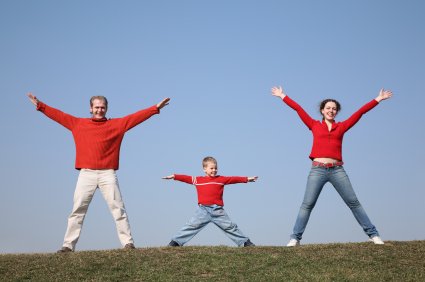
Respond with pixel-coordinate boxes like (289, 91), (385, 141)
(63, 169), (134, 250)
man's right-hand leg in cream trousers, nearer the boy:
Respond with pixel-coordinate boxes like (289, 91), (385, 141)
(99, 169), (134, 246)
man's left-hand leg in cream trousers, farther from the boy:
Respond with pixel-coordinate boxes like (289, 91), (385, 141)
(63, 169), (97, 250)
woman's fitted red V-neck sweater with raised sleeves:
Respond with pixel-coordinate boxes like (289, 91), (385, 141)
(283, 96), (378, 161)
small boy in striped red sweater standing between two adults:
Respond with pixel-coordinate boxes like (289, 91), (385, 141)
(163, 157), (258, 247)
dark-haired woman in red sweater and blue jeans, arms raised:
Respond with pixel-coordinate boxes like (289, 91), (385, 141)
(271, 86), (392, 247)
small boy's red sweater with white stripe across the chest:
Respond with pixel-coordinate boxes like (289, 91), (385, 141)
(174, 174), (248, 206)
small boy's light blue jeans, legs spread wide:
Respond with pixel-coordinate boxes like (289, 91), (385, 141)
(172, 205), (248, 246)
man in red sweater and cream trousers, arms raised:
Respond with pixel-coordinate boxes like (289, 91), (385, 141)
(28, 93), (170, 253)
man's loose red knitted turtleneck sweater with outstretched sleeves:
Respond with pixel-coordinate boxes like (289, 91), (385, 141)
(37, 102), (159, 170)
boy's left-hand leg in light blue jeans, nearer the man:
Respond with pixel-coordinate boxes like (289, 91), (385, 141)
(171, 205), (211, 246)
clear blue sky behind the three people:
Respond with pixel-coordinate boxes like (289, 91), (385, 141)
(0, 0), (425, 253)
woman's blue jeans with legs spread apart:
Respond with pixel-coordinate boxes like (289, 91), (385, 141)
(291, 166), (379, 240)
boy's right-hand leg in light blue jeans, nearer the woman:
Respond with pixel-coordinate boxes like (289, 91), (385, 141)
(208, 205), (249, 246)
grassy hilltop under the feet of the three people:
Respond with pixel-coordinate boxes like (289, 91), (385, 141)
(0, 241), (425, 281)
